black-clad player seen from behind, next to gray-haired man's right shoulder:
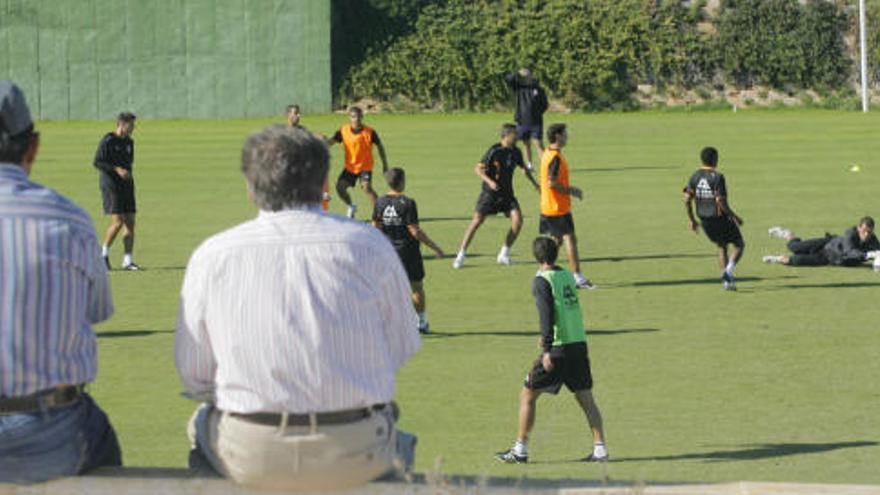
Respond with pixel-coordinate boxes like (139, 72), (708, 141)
(373, 167), (443, 333)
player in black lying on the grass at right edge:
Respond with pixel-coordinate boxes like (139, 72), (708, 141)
(763, 217), (880, 266)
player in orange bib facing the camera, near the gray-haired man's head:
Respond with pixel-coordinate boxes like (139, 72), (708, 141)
(327, 107), (388, 218)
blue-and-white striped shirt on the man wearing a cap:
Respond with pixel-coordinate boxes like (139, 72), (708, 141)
(0, 163), (113, 397)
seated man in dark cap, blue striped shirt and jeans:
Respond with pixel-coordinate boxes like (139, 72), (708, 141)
(0, 81), (121, 483)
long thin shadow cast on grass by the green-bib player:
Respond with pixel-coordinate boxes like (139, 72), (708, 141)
(604, 441), (880, 462)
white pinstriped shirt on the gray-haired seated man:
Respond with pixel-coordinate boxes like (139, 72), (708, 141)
(175, 206), (420, 414)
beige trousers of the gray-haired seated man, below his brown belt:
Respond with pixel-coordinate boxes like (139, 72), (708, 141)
(188, 406), (397, 491)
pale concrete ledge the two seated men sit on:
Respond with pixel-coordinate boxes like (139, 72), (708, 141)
(0, 468), (880, 495)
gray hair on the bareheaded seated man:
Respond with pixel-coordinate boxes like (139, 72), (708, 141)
(241, 125), (330, 211)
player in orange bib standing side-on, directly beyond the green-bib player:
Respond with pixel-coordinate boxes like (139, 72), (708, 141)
(539, 124), (596, 289)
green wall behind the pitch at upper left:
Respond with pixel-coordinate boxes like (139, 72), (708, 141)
(0, 0), (331, 120)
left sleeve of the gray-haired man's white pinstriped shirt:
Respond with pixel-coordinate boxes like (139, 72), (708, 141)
(174, 250), (217, 400)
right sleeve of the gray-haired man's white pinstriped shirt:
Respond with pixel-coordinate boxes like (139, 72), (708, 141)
(368, 240), (422, 369)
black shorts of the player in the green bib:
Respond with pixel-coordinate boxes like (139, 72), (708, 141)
(523, 342), (593, 394)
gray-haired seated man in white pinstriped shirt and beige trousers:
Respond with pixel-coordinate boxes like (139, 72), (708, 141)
(175, 126), (420, 490)
